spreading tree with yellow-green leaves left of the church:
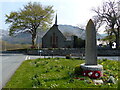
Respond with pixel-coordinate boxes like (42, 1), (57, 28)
(6, 2), (54, 46)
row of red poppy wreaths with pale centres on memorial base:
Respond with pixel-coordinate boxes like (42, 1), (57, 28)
(82, 70), (101, 78)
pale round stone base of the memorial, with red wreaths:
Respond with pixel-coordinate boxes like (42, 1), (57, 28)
(80, 64), (103, 78)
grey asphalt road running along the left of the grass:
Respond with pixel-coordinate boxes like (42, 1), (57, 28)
(0, 54), (26, 87)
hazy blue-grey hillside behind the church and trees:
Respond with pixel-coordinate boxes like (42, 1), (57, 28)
(0, 25), (103, 44)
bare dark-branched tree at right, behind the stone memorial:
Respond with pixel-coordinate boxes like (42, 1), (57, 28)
(93, 1), (120, 48)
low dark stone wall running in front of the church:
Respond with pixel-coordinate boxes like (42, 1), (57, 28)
(27, 48), (120, 56)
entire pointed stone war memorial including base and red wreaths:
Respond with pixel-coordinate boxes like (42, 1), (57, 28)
(80, 19), (103, 78)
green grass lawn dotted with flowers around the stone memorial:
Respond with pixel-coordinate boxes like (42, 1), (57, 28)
(4, 58), (120, 88)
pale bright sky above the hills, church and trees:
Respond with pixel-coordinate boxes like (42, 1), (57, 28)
(0, 0), (113, 33)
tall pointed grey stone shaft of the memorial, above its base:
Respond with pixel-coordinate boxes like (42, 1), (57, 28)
(85, 19), (97, 65)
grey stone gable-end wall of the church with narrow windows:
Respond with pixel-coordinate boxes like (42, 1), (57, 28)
(42, 25), (66, 48)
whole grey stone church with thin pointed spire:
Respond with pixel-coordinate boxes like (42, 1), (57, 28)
(42, 15), (74, 48)
